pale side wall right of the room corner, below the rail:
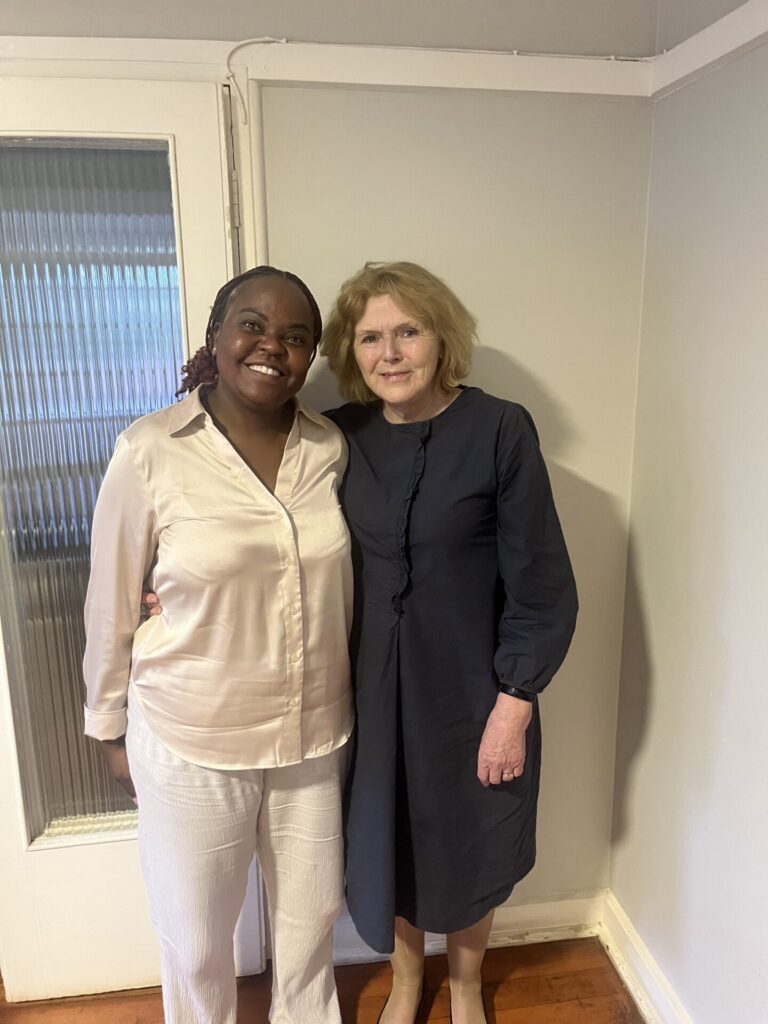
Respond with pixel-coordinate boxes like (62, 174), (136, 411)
(612, 39), (768, 1024)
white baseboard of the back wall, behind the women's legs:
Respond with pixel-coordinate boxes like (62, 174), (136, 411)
(334, 890), (605, 964)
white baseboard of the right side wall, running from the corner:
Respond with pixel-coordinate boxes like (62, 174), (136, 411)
(598, 890), (693, 1024)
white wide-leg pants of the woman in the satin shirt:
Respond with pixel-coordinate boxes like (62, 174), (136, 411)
(126, 698), (343, 1024)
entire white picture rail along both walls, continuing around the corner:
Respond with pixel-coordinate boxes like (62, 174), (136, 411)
(0, 0), (768, 99)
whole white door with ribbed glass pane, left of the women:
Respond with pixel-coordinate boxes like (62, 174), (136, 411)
(0, 82), (262, 999)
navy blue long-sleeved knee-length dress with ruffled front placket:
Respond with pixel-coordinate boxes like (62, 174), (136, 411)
(328, 388), (577, 952)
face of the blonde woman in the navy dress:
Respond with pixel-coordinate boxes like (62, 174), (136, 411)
(354, 295), (444, 418)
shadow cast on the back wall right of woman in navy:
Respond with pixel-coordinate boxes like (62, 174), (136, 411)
(471, 346), (650, 888)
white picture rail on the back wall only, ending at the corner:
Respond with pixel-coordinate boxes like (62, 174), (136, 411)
(0, 36), (650, 97)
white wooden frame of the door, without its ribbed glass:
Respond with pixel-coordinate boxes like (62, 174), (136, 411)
(0, 78), (264, 1001)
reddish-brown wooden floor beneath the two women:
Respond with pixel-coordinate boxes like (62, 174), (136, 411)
(0, 939), (642, 1024)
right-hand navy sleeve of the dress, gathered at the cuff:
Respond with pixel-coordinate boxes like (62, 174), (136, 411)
(494, 406), (579, 694)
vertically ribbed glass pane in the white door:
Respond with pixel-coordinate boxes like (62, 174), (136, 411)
(0, 138), (183, 838)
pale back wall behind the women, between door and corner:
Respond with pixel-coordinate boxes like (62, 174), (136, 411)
(264, 88), (650, 901)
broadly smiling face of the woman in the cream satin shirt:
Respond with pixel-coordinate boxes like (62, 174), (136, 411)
(213, 275), (314, 412)
